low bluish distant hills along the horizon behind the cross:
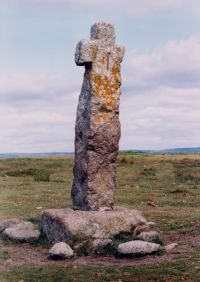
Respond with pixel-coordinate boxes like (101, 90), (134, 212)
(0, 147), (200, 159)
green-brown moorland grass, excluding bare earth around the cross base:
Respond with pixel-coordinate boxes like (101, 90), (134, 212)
(0, 155), (200, 281)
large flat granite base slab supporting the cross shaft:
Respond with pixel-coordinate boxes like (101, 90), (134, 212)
(41, 207), (147, 242)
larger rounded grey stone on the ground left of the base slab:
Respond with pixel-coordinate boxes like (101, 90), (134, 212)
(3, 222), (40, 242)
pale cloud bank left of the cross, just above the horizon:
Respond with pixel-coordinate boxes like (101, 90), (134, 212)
(0, 86), (79, 152)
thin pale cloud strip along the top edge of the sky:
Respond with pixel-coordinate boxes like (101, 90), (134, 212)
(2, 0), (200, 15)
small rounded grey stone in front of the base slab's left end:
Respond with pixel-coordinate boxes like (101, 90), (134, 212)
(49, 242), (74, 259)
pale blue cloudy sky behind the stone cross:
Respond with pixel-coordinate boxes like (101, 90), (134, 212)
(0, 0), (200, 153)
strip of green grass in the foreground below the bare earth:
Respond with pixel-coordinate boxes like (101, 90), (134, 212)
(0, 260), (198, 282)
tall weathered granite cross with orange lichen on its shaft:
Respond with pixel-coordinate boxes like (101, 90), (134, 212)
(71, 22), (124, 210)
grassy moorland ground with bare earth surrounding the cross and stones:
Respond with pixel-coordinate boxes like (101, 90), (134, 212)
(0, 153), (200, 282)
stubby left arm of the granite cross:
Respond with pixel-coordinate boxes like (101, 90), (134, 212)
(75, 39), (98, 66)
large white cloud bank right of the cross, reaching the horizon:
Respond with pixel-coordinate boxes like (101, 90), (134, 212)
(121, 37), (200, 149)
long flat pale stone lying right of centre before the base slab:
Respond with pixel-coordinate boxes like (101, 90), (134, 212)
(117, 240), (160, 256)
